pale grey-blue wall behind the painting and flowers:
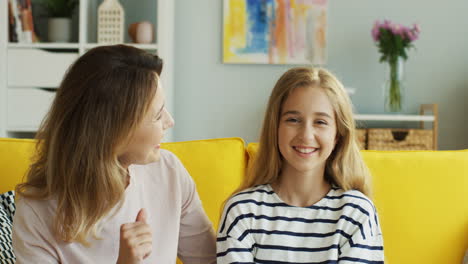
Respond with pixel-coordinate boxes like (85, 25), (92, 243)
(174, 0), (468, 149)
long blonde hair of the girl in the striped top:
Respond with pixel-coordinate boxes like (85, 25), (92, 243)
(241, 67), (370, 196)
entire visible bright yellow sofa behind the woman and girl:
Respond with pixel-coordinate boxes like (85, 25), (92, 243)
(0, 138), (468, 264)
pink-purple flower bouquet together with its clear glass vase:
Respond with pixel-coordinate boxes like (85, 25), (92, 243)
(372, 20), (420, 112)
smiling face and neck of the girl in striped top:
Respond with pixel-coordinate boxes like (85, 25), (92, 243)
(278, 87), (337, 173)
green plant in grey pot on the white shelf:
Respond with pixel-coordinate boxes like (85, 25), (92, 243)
(42, 0), (78, 42)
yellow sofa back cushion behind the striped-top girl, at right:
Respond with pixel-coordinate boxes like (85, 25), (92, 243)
(247, 143), (468, 264)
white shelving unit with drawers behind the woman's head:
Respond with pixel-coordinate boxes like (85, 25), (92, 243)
(0, 0), (175, 141)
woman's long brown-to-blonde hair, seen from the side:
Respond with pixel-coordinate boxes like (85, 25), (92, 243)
(16, 45), (162, 245)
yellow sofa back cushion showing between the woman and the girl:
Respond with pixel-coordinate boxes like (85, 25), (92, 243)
(161, 138), (246, 229)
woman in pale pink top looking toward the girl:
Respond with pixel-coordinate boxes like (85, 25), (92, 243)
(13, 45), (216, 264)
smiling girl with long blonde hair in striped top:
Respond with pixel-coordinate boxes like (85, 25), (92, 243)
(217, 68), (384, 264)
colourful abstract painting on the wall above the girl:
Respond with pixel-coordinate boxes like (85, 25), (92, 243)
(223, 0), (327, 65)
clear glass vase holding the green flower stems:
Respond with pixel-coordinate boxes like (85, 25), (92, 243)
(383, 57), (405, 113)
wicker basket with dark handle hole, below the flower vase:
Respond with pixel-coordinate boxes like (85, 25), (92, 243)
(367, 128), (433, 150)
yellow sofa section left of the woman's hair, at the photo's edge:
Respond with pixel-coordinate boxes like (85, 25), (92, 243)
(0, 138), (36, 193)
